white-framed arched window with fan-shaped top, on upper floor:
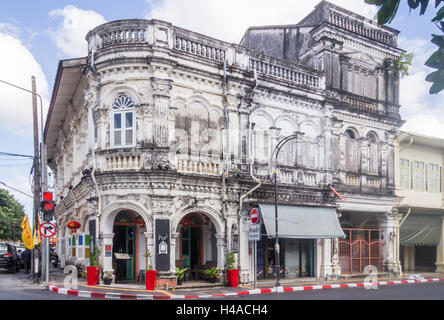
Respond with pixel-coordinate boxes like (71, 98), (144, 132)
(111, 95), (136, 147)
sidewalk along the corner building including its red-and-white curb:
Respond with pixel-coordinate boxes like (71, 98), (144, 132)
(46, 272), (444, 300)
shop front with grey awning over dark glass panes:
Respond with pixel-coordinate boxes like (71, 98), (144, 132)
(256, 204), (344, 279)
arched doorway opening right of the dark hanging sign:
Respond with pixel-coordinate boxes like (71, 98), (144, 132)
(176, 213), (217, 278)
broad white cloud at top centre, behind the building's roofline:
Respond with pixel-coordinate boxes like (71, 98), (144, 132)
(147, 0), (376, 43)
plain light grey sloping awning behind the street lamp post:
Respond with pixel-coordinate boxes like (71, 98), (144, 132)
(259, 204), (345, 239)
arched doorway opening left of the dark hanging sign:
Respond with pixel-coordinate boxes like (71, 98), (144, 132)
(112, 210), (145, 282)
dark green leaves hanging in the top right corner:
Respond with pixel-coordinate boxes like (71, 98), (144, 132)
(365, 0), (444, 94)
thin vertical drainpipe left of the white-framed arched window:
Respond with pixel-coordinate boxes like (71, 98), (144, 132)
(87, 50), (102, 255)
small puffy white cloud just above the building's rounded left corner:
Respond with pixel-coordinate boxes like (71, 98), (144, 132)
(49, 5), (106, 58)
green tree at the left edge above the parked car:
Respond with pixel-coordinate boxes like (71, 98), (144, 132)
(0, 189), (25, 240)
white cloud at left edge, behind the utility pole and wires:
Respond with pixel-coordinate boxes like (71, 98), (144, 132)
(0, 32), (48, 137)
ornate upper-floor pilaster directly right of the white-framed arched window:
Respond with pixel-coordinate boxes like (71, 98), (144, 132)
(151, 77), (173, 147)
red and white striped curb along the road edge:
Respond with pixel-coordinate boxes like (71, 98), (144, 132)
(46, 278), (444, 300)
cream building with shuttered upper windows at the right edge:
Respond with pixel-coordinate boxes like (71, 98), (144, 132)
(395, 132), (444, 272)
